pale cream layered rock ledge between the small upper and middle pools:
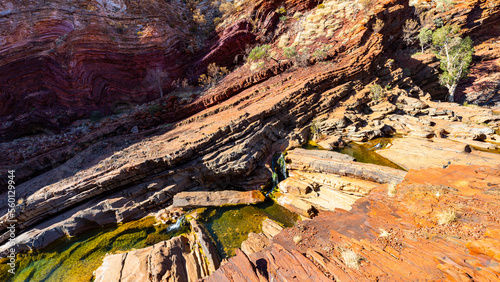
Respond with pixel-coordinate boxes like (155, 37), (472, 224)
(275, 149), (406, 218)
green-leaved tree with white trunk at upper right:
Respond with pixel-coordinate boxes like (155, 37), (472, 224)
(432, 26), (474, 102)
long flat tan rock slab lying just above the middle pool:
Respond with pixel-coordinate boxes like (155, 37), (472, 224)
(172, 190), (266, 208)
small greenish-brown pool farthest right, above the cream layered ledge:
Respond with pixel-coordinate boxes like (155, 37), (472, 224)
(339, 138), (404, 170)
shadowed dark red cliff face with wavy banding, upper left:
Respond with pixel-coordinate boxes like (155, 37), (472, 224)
(0, 1), (266, 140)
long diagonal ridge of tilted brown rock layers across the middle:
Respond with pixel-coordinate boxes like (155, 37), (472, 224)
(2, 1), (500, 253)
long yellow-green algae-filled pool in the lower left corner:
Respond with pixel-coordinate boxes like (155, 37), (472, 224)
(0, 217), (187, 282)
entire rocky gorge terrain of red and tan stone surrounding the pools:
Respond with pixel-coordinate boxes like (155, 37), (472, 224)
(0, 0), (500, 281)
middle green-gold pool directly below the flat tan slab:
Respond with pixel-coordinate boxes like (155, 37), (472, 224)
(200, 199), (299, 257)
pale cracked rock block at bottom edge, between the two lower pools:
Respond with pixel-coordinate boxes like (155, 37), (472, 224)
(95, 220), (220, 282)
